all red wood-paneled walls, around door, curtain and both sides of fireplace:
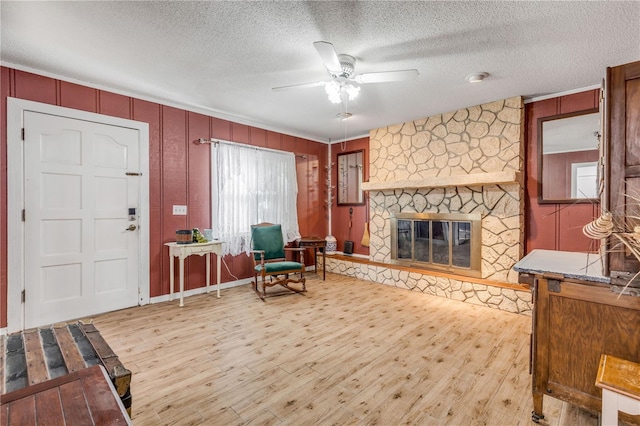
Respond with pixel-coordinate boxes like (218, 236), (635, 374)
(0, 67), (599, 327)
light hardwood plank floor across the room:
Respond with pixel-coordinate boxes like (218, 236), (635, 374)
(93, 274), (598, 426)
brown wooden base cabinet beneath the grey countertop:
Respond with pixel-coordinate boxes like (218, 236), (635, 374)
(531, 273), (640, 424)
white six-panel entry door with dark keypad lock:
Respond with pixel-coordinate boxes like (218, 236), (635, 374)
(24, 111), (140, 328)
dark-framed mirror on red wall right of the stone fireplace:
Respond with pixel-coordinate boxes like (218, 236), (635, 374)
(538, 110), (600, 202)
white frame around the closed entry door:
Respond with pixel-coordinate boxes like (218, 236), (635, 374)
(7, 97), (149, 333)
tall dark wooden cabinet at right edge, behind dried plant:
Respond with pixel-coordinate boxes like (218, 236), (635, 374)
(603, 61), (640, 287)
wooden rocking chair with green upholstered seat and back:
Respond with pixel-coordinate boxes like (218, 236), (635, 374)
(251, 223), (307, 300)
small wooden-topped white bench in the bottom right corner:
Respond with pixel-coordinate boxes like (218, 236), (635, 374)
(596, 354), (640, 426)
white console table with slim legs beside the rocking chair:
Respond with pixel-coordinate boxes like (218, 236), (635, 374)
(165, 241), (222, 306)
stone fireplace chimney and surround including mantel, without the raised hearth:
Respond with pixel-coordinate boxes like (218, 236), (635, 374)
(363, 97), (524, 283)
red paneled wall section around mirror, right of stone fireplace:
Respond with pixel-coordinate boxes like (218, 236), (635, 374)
(525, 89), (600, 253)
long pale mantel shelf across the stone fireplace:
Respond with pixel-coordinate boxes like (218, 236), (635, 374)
(362, 170), (520, 191)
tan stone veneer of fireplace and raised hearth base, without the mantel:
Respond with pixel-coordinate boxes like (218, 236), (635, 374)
(327, 97), (531, 313)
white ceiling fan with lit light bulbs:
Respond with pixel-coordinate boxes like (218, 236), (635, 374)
(273, 41), (418, 104)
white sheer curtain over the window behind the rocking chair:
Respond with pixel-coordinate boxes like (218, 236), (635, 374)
(211, 142), (300, 256)
